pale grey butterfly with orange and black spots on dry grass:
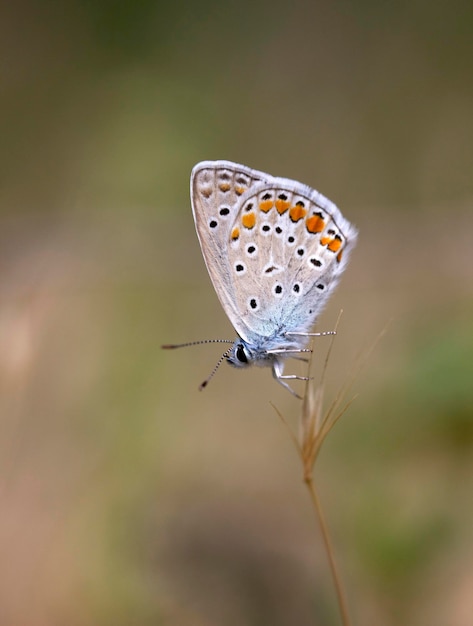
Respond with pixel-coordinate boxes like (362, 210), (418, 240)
(163, 161), (357, 396)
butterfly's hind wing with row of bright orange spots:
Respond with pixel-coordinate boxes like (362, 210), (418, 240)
(223, 178), (357, 343)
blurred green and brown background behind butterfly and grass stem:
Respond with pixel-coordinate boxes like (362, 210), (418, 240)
(0, 0), (473, 626)
